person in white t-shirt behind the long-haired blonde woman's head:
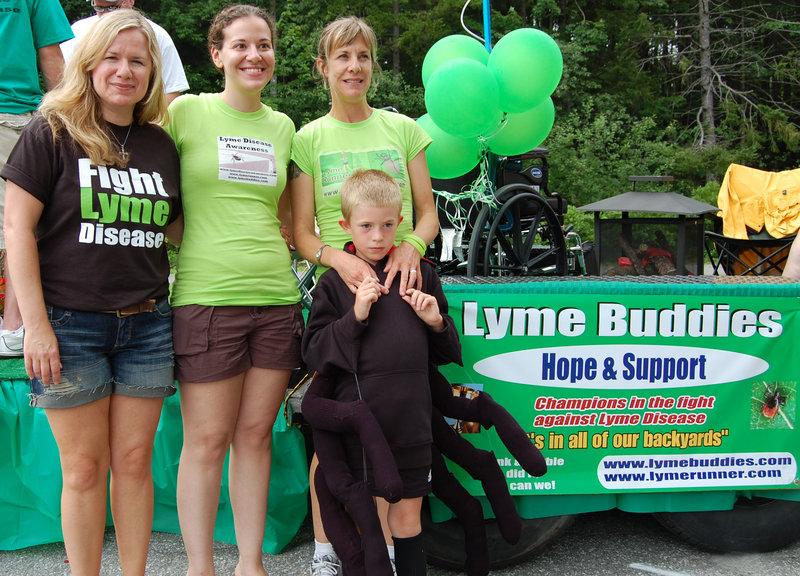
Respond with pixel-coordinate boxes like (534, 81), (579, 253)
(61, 0), (189, 104)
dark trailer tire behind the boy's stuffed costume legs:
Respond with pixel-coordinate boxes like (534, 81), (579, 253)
(422, 503), (575, 571)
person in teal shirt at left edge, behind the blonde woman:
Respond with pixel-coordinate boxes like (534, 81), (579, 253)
(0, 0), (72, 357)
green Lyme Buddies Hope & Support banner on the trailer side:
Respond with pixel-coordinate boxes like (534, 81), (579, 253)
(443, 279), (800, 495)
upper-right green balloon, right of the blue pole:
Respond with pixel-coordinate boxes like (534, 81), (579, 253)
(488, 28), (564, 114)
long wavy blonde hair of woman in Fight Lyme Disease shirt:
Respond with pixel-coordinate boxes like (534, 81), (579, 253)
(39, 9), (167, 167)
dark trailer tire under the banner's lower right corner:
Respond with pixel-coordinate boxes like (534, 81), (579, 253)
(655, 498), (800, 552)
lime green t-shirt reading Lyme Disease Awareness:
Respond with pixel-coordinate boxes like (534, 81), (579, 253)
(165, 94), (300, 306)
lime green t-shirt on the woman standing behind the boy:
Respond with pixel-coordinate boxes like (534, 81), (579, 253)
(292, 109), (431, 254)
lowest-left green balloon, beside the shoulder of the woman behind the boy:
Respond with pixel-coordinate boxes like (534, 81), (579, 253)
(417, 114), (481, 180)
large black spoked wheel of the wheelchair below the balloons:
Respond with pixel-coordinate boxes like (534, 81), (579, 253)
(467, 184), (567, 276)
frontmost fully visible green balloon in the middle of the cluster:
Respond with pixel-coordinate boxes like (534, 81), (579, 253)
(425, 58), (499, 138)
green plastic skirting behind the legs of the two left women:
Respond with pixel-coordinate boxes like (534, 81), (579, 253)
(0, 359), (308, 554)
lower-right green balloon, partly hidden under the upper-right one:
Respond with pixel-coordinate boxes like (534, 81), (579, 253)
(486, 97), (556, 156)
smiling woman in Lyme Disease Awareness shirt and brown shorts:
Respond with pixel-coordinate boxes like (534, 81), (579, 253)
(167, 5), (303, 576)
